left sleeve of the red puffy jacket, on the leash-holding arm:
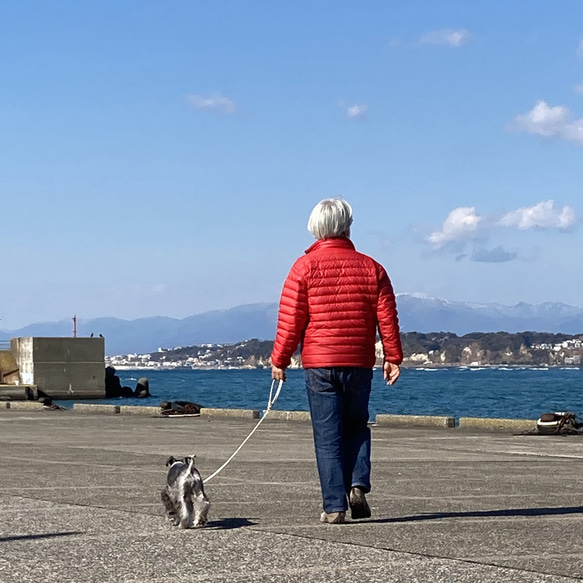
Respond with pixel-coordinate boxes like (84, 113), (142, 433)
(271, 258), (309, 369)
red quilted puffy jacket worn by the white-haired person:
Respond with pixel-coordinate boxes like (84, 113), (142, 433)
(271, 237), (403, 369)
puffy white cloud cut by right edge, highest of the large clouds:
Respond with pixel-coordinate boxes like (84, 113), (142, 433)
(508, 99), (583, 144)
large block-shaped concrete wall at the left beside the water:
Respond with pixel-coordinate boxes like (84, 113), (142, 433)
(10, 337), (105, 399)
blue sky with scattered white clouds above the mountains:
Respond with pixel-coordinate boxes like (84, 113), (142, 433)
(0, 0), (583, 329)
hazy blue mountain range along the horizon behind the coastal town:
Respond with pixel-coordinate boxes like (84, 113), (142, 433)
(0, 294), (583, 355)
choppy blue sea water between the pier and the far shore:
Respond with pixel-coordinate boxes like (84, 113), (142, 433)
(84, 367), (583, 420)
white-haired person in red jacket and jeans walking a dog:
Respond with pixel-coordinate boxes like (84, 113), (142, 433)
(271, 199), (403, 524)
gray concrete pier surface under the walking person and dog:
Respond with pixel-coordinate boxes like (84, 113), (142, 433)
(0, 410), (583, 583)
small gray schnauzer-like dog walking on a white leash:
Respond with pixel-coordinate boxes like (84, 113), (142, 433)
(161, 456), (211, 528)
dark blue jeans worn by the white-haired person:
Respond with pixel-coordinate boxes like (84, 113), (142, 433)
(305, 367), (372, 513)
